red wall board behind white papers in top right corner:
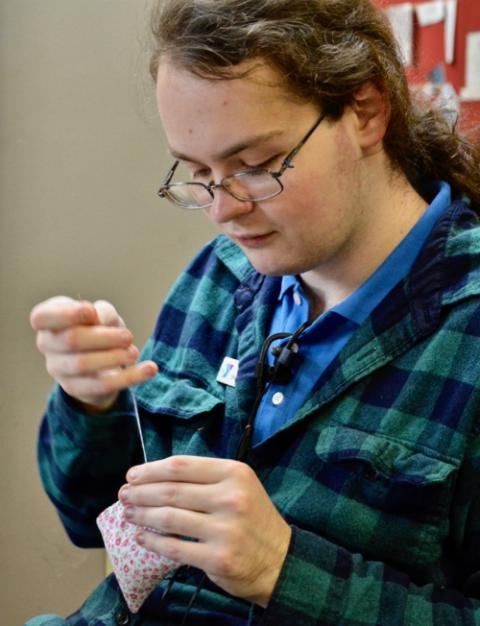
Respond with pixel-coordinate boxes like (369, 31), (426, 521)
(377, 0), (480, 126)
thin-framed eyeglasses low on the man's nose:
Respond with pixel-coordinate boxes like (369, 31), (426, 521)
(157, 114), (325, 209)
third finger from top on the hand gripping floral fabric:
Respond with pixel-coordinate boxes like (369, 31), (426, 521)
(125, 506), (209, 540)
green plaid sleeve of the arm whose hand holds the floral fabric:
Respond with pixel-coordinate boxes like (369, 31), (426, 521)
(257, 438), (480, 626)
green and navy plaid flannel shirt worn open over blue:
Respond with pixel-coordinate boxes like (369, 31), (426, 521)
(28, 196), (480, 626)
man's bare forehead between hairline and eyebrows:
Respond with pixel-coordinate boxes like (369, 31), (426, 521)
(156, 61), (313, 154)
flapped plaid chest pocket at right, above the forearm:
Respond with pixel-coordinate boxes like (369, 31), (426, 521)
(315, 426), (458, 566)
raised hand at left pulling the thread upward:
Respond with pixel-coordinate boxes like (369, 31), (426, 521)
(30, 296), (158, 412)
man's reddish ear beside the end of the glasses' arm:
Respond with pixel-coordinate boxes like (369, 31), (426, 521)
(352, 82), (390, 154)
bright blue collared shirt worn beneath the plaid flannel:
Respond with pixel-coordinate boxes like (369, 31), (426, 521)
(253, 183), (451, 445)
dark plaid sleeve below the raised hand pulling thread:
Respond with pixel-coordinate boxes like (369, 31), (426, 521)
(38, 386), (142, 547)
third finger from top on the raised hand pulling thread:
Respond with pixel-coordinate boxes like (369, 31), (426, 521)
(47, 346), (139, 378)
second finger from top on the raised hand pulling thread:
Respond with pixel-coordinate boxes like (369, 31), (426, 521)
(37, 326), (133, 354)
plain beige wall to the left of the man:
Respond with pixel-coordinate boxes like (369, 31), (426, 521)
(0, 0), (213, 626)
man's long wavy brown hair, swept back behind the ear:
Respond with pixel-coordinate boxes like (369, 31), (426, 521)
(150, 0), (480, 210)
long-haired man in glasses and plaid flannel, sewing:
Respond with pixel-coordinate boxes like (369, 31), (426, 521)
(28, 0), (480, 626)
